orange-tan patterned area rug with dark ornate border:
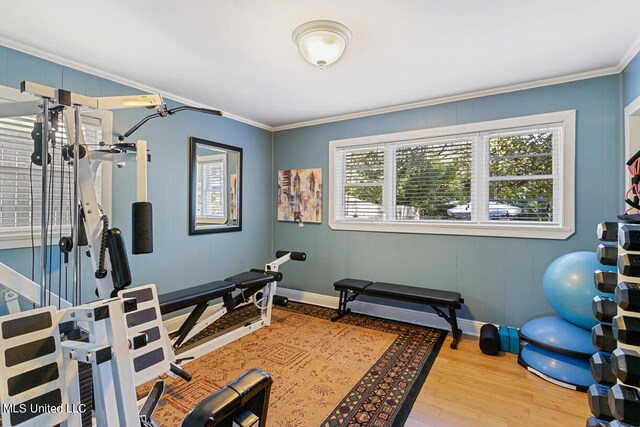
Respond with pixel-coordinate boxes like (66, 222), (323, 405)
(138, 302), (446, 427)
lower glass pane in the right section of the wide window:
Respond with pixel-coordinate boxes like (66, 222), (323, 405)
(489, 179), (553, 222)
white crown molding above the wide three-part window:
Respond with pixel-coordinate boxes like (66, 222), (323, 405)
(273, 66), (620, 132)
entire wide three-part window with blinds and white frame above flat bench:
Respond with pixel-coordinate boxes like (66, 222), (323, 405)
(329, 111), (575, 238)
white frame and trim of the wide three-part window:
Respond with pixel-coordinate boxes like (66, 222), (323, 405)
(329, 110), (576, 239)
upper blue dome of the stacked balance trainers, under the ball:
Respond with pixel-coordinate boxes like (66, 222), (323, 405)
(520, 317), (598, 361)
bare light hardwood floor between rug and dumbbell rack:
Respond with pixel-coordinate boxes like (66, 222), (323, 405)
(405, 336), (591, 427)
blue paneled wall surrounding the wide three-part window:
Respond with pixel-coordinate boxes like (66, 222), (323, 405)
(272, 75), (623, 326)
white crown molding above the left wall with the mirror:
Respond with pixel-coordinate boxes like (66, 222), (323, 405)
(0, 36), (273, 132)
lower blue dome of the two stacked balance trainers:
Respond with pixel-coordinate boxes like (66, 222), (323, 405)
(518, 344), (596, 391)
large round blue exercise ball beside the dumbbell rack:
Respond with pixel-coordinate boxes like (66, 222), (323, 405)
(542, 251), (616, 329)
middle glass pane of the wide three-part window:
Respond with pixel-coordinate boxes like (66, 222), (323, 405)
(395, 141), (471, 220)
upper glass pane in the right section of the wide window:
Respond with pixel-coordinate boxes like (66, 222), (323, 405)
(489, 131), (553, 176)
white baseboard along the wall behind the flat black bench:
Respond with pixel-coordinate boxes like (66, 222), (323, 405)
(277, 287), (484, 336)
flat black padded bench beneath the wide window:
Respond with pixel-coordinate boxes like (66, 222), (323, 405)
(331, 279), (464, 349)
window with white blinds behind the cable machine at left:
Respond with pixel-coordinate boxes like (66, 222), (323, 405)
(0, 116), (102, 233)
